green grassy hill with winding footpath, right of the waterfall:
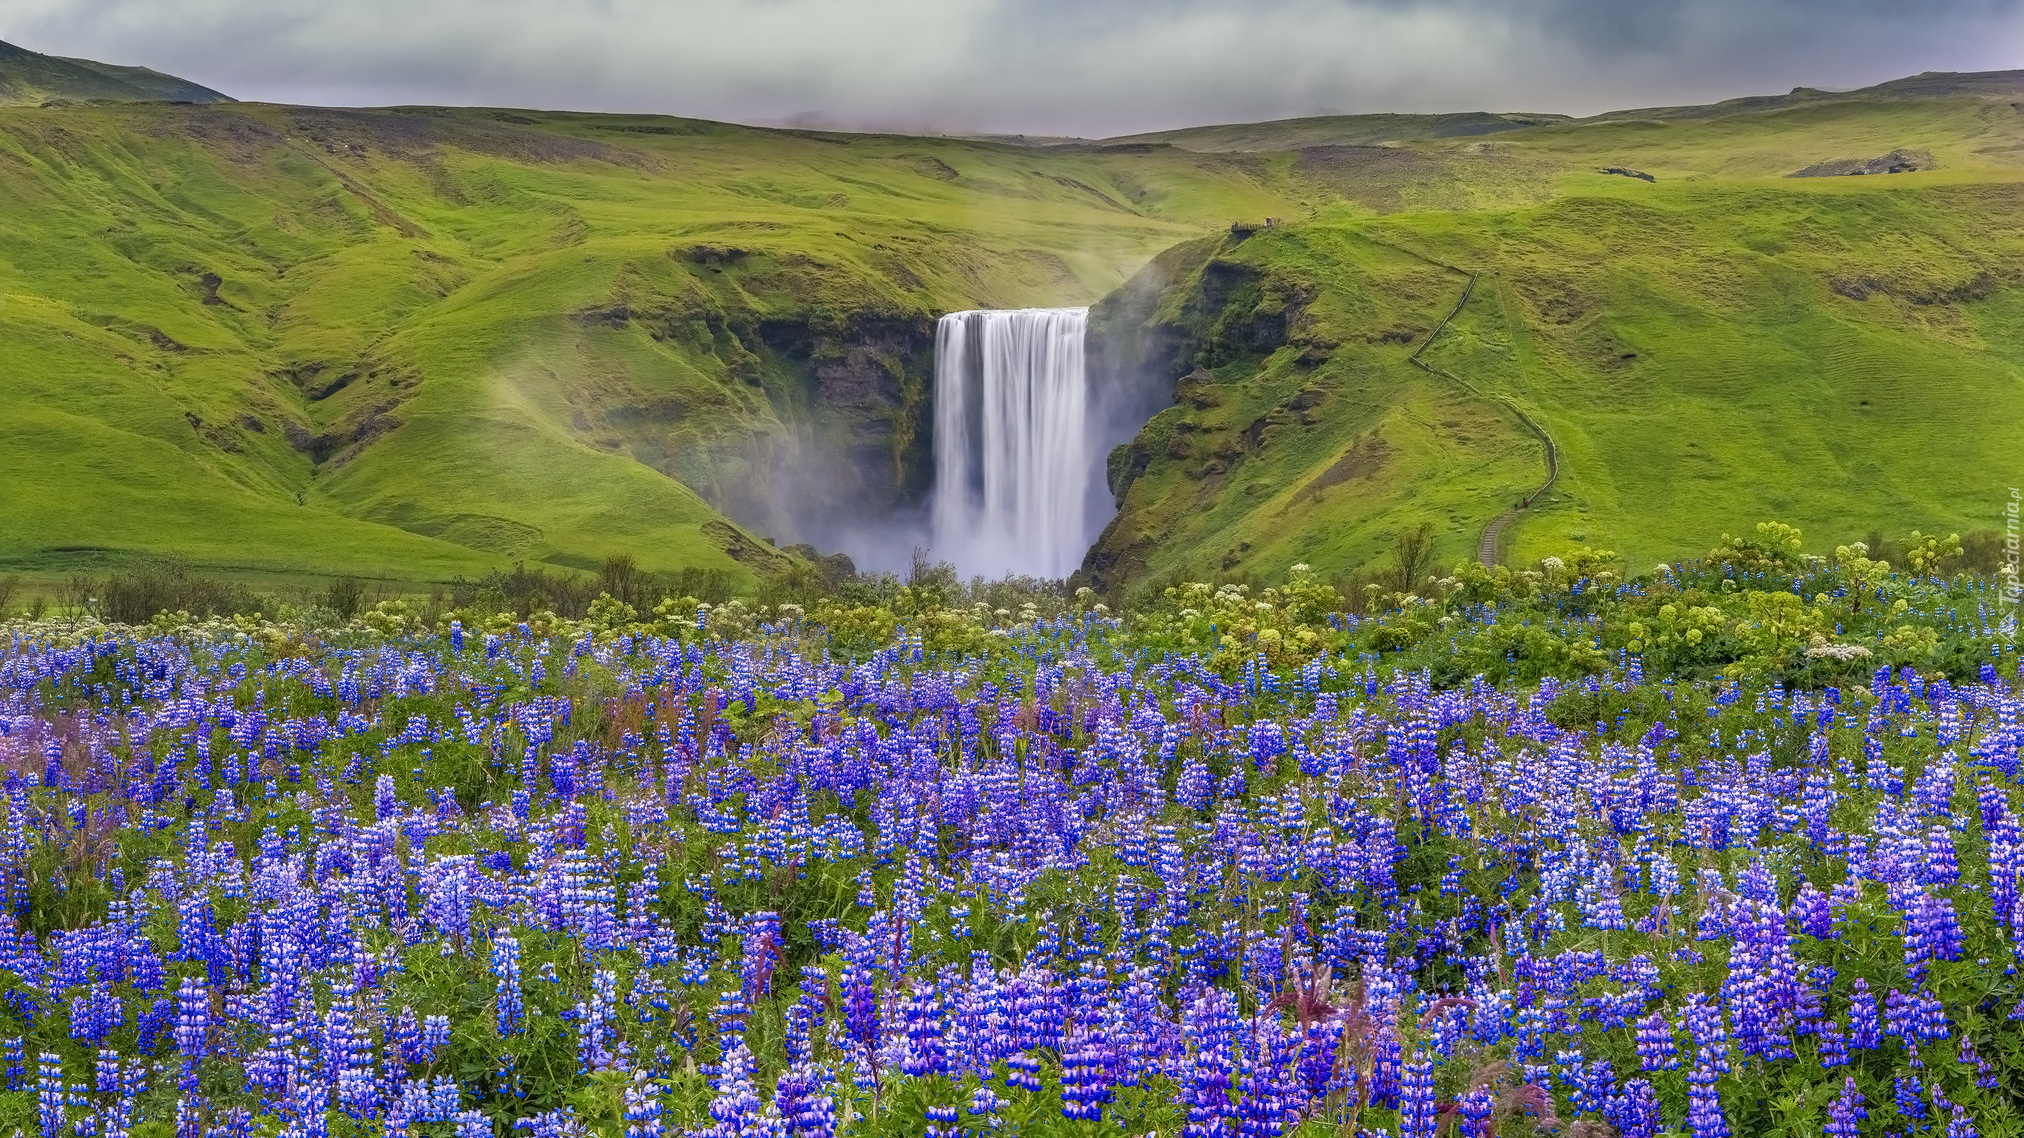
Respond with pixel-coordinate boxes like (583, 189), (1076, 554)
(1089, 87), (2024, 581)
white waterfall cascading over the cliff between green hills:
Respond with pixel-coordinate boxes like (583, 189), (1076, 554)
(933, 308), (1103, 577)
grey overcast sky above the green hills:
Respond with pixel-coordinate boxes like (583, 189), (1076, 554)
(0, 0), (2024, 138)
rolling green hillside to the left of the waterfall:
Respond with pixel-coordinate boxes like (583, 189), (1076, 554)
(0, 103), (1301, 577)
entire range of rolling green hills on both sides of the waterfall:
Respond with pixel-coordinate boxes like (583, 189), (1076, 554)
(0, 77), (2024, 583)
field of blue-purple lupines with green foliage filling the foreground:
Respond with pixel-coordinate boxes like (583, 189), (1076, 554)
(0, 526), (2024, 1138)
